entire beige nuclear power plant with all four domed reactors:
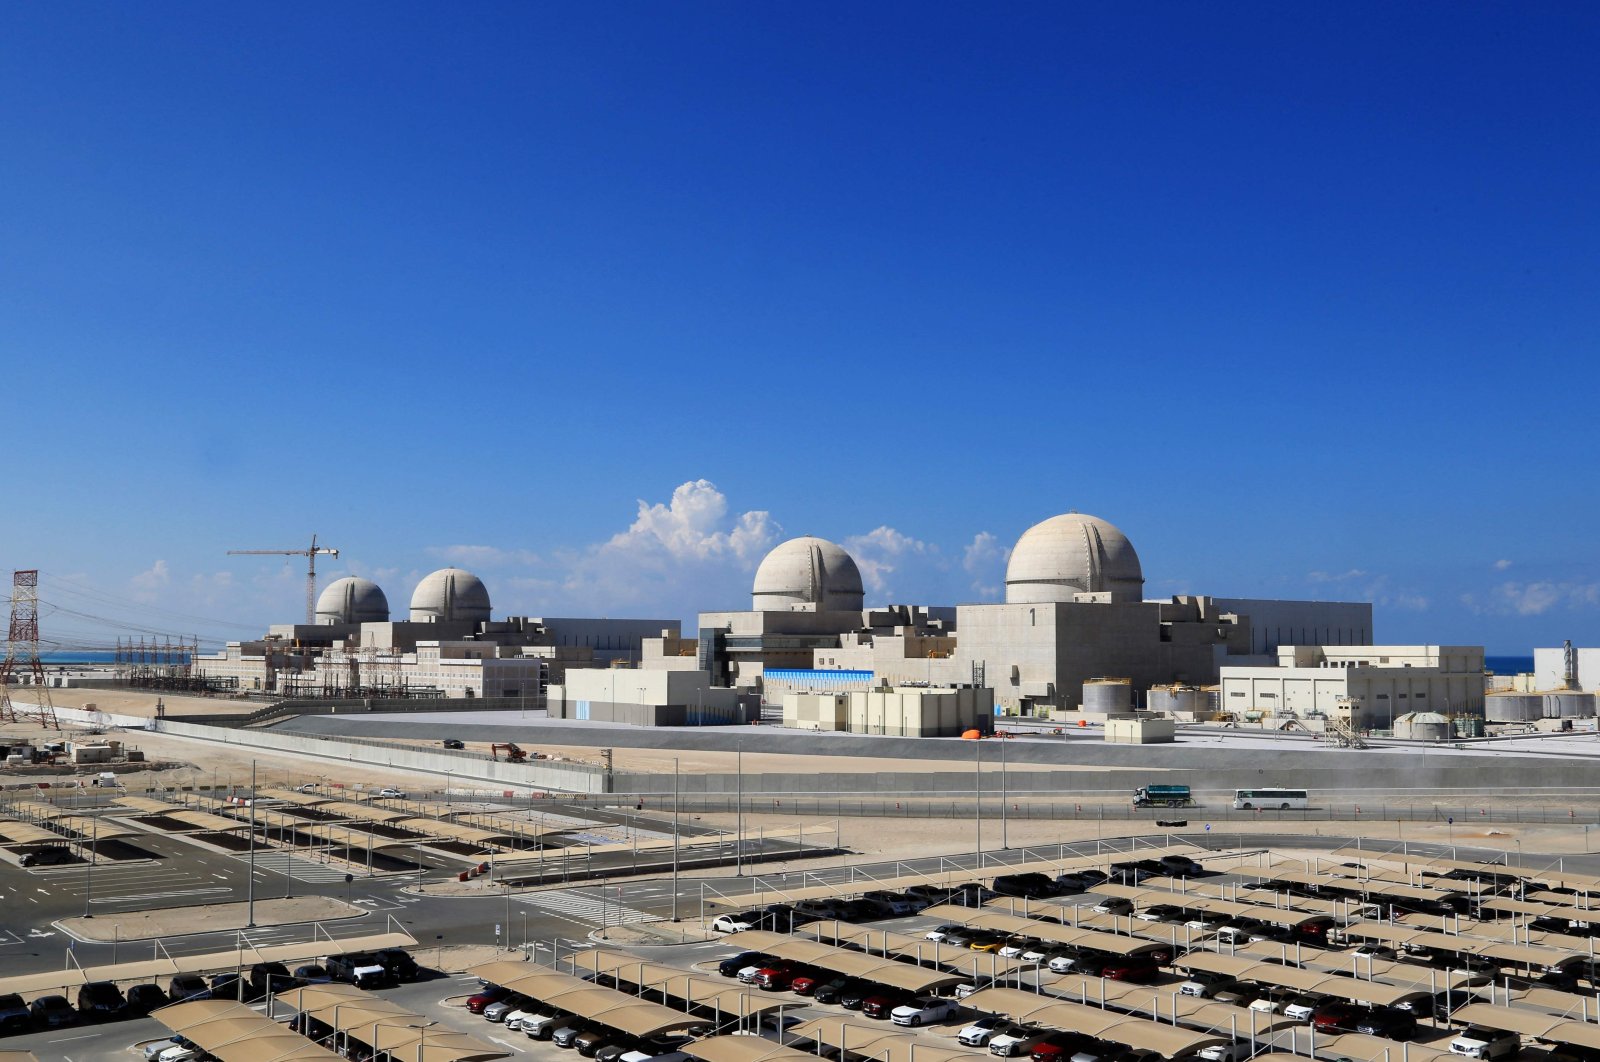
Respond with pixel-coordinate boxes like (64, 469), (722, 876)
(198, 512), (1504, 739)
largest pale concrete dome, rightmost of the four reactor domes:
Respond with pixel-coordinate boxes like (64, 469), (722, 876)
(1005, 512), (1144, 605)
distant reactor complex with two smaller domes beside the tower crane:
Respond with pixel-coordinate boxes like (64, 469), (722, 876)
(197, 568), (680, 707)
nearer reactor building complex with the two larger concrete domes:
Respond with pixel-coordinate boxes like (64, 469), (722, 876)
(643, 513), (1373, 715)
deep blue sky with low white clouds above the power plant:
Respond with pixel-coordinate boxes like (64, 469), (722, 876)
(0, 3), (1600, 653)
